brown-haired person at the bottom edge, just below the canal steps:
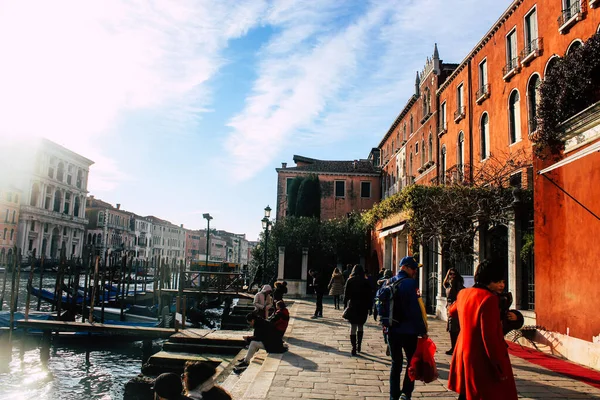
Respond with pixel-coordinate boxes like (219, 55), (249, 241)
(181, 361), (231, 400)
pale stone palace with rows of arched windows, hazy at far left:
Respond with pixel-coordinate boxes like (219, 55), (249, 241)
(14, 139), (93, 259)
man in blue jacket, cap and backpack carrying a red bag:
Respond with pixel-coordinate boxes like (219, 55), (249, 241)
(387, 256), (427, 400)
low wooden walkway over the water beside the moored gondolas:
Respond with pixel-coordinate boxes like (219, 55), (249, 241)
(16, 319), (176, 340)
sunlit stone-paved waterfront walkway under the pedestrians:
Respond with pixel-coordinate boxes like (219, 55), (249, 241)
(223, 299), (600, 400)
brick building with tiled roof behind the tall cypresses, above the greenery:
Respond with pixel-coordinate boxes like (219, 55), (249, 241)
(276, 156), (381, 220)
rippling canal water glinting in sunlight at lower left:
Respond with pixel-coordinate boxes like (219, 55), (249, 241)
(0, 275), (162, 400)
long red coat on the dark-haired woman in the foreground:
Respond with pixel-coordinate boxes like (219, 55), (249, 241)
(448, 288), (517, 400)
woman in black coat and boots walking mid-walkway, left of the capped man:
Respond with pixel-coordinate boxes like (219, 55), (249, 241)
(344, 264), (373, 356)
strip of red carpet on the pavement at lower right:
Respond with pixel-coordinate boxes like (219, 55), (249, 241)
(507, 342), (600, 389)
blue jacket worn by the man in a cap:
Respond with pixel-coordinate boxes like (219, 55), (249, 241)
(389, 270), (427, 335)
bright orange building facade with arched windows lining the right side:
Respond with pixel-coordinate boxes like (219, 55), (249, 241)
(372, 0), (600, 367)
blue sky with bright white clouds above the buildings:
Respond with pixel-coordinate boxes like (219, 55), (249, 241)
(0, 0), (511, 240)
